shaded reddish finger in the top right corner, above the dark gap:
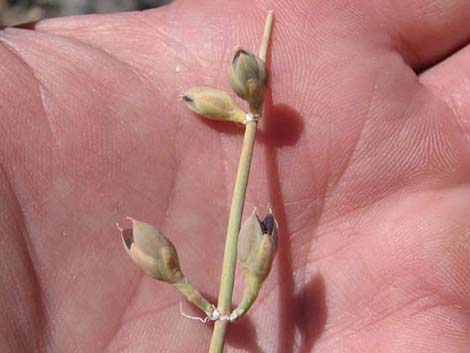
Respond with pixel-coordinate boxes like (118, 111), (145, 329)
(376, 0), (470, 70)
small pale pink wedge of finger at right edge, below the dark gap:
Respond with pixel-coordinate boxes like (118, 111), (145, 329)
(420, 45), (470, 141)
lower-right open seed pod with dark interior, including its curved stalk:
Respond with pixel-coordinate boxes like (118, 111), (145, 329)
(231, 212), (279, 320)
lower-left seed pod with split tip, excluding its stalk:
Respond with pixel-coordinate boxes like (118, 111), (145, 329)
(122, 218), (184, 284)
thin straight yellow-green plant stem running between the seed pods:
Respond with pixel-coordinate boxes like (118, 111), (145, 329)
(209, 11), (272, 353)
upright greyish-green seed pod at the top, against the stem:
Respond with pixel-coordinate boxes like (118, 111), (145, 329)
(228, 48), (268, 113)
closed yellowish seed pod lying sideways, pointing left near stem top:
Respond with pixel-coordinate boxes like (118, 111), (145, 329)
(183, 87), (245, 123)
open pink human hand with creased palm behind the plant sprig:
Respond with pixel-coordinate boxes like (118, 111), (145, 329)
(0, 0), (470, 353)
